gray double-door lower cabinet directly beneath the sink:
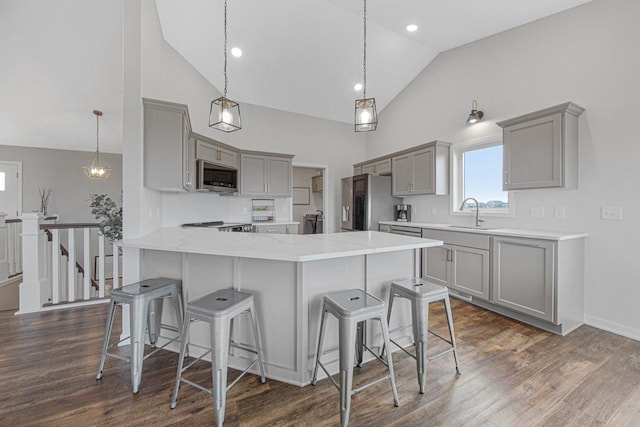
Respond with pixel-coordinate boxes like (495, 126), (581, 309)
(422, 229), (490, 300)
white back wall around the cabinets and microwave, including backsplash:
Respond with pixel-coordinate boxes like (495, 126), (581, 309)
(140, 0), (365, 231)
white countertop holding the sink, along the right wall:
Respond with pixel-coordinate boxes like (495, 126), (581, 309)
(379, 221), (588, 240)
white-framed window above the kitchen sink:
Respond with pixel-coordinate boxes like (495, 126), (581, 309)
(452, 138), (513, 216)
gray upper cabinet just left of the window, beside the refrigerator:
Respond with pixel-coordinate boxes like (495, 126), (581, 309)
(391, 141), (451, 197)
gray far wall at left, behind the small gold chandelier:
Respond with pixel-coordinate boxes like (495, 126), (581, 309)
(0, 145), (122, 223)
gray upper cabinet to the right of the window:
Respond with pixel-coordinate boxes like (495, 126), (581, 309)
(497, 102), (584, 191)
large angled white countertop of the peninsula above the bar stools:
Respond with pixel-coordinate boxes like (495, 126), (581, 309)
(122, 227), (443, 262)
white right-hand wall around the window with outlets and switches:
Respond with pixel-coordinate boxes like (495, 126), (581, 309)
(367, 0), (640, 339)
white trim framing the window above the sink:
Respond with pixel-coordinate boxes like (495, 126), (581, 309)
(449, 133), (516, 218)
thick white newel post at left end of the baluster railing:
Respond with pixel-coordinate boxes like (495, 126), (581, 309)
(18, 213), (47, 314)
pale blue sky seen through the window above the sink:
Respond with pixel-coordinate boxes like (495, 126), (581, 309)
(464, 145), (509, 208)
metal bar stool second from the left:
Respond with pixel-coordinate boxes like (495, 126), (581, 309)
(171, 289), (266, 426)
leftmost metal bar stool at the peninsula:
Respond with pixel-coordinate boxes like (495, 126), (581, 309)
(96, 278), (182, 394)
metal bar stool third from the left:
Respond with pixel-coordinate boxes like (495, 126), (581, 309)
(311, 289), (400, 427)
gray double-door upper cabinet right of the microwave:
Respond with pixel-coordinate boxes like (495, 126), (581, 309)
(240, 153), (293, 197)
